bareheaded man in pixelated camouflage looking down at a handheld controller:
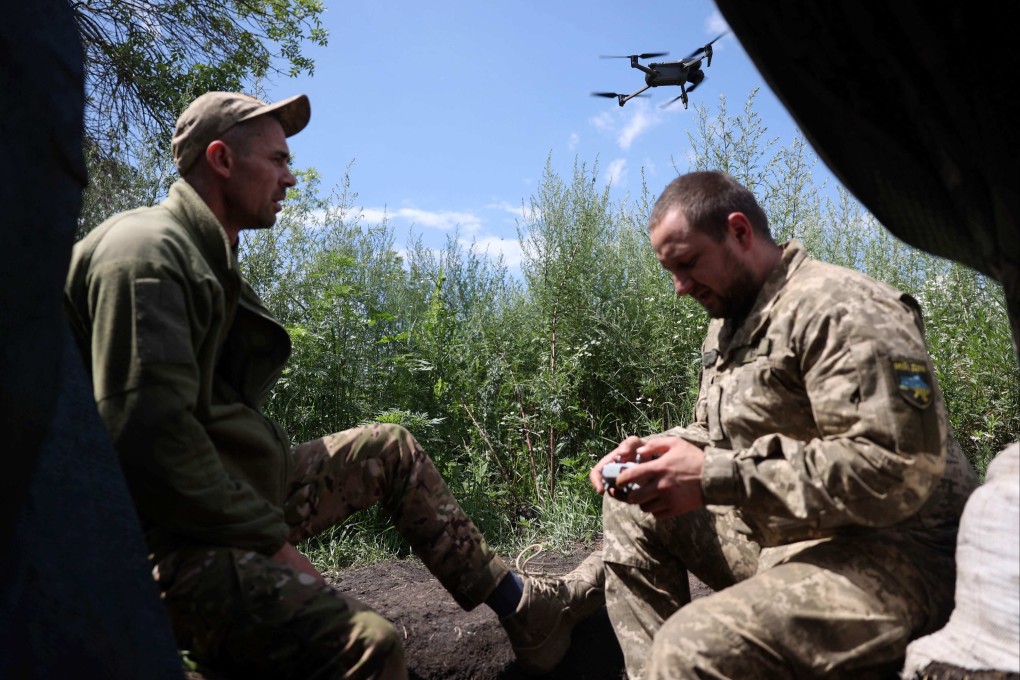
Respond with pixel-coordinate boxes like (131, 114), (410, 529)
(592, 172), (976, 679)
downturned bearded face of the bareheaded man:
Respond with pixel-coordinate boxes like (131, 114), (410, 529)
(651, 210), (761, 319)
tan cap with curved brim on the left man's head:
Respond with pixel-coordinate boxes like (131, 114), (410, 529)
(172, 92), (312, 174)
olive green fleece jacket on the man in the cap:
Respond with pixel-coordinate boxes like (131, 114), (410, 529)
(64, 180), (291, 561)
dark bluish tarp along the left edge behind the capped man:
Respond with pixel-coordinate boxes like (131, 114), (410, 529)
(0, 0), (184, 680)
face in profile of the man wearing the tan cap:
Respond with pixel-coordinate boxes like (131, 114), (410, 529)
(225, 115), (297, 229)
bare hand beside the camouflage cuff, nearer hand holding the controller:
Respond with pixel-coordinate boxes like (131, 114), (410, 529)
(616, 436), (705, 519)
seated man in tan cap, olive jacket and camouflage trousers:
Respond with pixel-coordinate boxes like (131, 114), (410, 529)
(65, 92), (604, 680)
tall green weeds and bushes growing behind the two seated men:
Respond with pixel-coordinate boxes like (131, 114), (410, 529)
(89, 82), (1020, 569)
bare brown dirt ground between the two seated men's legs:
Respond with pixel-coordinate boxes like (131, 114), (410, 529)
(327, 546), (711, 680)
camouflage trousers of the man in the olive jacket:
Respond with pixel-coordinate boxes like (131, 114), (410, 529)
(154, 424), (508, 680)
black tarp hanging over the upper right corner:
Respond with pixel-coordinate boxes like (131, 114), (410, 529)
(716, 0), (1020, 369)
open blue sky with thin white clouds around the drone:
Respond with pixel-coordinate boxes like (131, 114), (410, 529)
(265, 0), (821, 267)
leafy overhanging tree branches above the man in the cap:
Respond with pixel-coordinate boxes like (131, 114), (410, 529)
(70, 0), (327, 156)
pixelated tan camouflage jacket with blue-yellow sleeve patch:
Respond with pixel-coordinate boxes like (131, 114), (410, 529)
(669, 241), (976, 546)
